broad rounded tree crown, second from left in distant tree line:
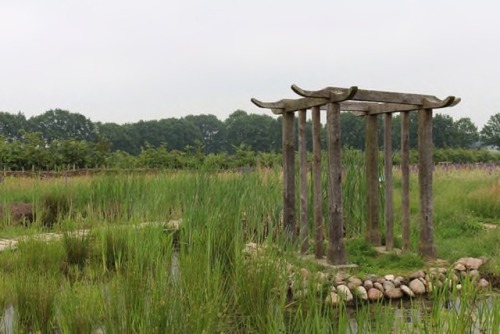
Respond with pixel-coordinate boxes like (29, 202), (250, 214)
(28, 109), (97, 143)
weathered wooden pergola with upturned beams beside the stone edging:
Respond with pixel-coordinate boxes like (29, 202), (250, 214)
(252, 85), (460, 264)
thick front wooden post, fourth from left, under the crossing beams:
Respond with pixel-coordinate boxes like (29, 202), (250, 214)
(326, 103), (346, 264)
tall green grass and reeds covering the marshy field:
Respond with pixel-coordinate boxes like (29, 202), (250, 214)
(0, 168), (500, 333)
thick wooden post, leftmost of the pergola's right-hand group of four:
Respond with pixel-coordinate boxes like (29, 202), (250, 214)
(365, 115), (381, 246)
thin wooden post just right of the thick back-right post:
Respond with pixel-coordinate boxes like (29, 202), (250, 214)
(384, 113), (394, 251)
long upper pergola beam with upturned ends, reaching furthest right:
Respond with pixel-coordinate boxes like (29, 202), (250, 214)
(292, 85), (460, 110)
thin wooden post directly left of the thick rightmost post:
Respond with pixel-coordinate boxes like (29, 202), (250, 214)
(401, 111), (410, 251)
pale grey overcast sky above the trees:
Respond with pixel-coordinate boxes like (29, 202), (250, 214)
(0, 0), (500, 129)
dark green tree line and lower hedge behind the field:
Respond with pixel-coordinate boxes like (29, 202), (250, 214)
(0, 109), (500, 170)
